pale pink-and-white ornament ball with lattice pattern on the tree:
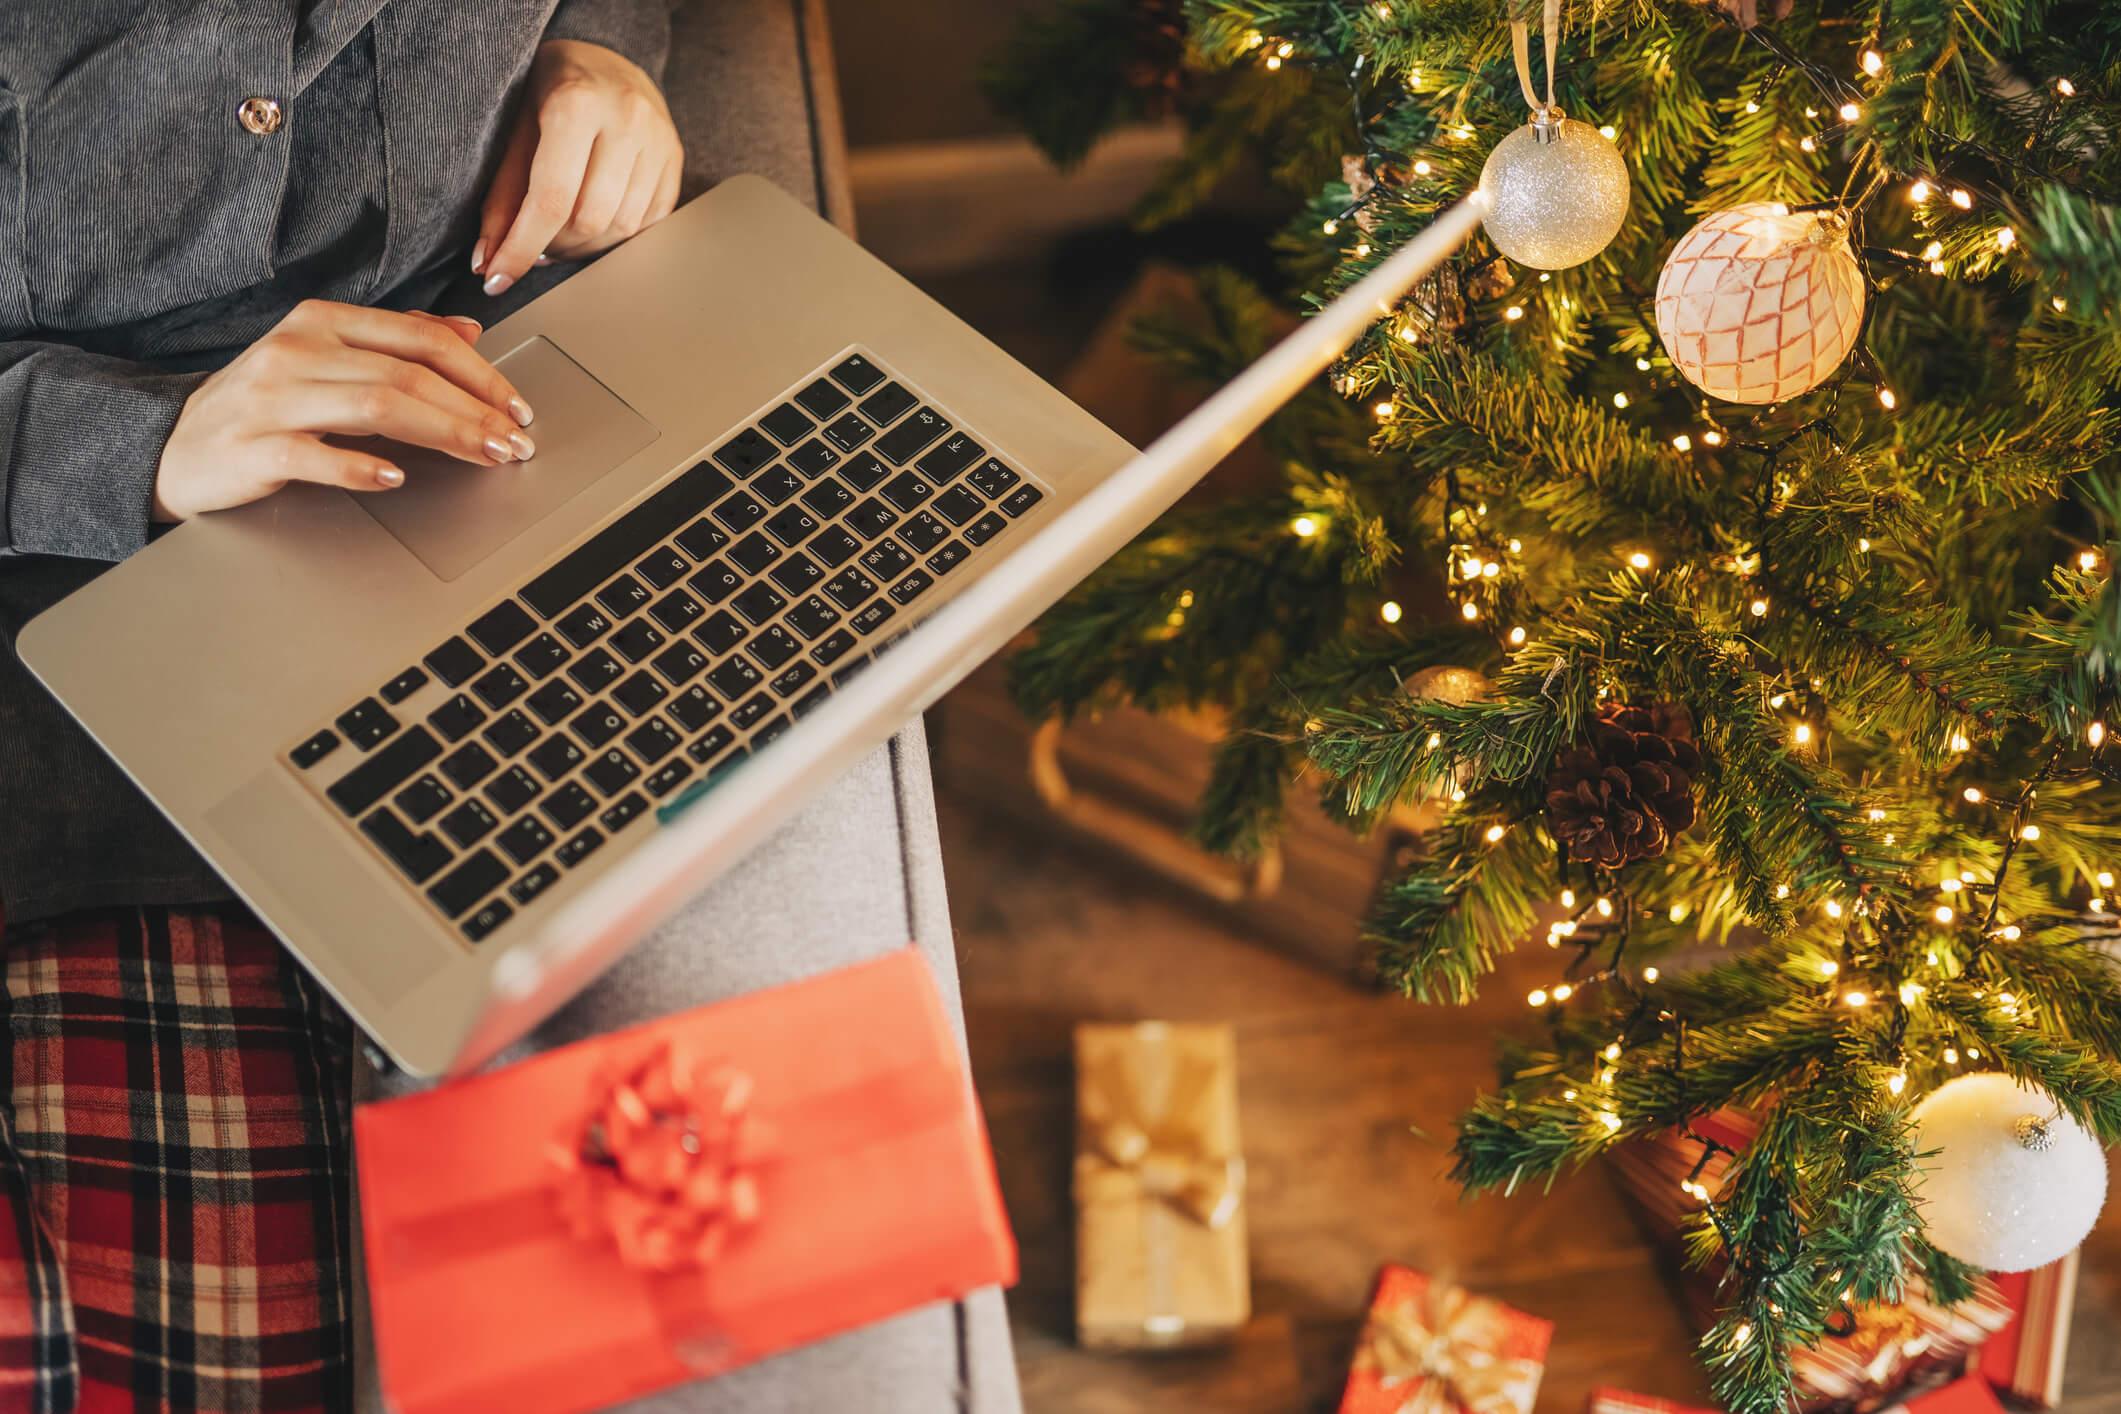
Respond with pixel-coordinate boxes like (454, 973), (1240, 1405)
(1657, 201), (1864, 403)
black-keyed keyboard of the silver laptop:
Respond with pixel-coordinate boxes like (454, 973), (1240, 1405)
(286, 352), (1046, 943)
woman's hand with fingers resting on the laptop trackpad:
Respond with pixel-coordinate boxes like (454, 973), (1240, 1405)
(155, 299), (537, 522)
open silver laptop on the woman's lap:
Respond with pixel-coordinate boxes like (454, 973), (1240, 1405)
(17, 178), (1478, 1075)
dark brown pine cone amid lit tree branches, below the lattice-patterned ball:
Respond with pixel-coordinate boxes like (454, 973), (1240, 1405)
(1546, 702), (1701, 869)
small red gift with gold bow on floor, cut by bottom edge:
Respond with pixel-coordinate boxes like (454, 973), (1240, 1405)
(1340, 1263), (1555, 1414)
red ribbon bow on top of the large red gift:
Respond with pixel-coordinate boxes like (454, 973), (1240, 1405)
(551, 1043), (772, 1272)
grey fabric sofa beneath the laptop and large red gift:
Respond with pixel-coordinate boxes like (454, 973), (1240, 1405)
(354, 0), (1020, 1414)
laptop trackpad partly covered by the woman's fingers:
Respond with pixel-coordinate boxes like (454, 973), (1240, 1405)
(354, 335), (658, 579)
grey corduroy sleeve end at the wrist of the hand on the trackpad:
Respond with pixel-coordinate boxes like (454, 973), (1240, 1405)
(0, 341), (206, 560)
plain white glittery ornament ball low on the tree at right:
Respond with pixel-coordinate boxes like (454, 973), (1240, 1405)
(1915, 1073), (2106, 1272)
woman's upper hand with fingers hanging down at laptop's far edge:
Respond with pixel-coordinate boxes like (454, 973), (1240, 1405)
(471, 40), (685, 295)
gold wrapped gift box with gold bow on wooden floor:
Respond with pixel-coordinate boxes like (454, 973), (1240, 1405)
(1075, 1022), (1251, 1348)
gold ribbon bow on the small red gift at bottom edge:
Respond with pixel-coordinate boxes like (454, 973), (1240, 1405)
(1355, 1283), (1540, 1414)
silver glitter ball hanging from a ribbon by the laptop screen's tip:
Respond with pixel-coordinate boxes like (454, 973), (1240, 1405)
(1480, 119), (1627, 269)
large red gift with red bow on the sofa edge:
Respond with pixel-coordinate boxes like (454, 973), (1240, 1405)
(354, 950), (1016, 1414)
